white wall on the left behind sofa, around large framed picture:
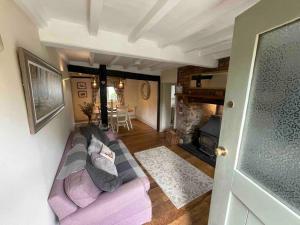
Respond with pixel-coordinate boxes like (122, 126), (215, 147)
(0, 0), (73, 225)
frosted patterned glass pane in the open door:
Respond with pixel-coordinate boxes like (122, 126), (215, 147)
(238, 21), (300, 213)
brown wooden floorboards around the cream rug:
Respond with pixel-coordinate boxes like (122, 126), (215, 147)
(118, 120), (214, 225)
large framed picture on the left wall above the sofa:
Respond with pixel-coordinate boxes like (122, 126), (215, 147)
(18, 48), (64, 134)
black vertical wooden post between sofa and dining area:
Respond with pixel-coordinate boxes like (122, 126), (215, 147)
(99, 65), (108, 126)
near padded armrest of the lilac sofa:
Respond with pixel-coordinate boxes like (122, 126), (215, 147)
(60, 178), (151, 225)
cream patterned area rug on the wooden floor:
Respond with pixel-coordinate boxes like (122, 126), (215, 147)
(134, 146), (213, 209)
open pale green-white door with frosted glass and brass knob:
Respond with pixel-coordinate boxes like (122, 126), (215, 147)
(209, 0), (300, 225)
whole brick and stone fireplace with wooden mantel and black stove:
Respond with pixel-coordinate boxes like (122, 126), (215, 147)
(176, 62), (229, 166)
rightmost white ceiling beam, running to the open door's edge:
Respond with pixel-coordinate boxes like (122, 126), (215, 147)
(182, 26), (233, 53)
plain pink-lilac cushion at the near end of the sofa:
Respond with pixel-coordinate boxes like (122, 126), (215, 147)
(64, 169), (101, 208)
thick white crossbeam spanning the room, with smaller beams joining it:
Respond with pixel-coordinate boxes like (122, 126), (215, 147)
(39, 20), (217, 68)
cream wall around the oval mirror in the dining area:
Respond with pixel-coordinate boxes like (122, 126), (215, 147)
(136, 81), (158, 129)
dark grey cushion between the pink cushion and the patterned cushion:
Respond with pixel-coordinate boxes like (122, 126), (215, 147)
(86, 156), (122, 192)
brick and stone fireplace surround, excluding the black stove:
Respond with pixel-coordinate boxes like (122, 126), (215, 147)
(176, 58), (229, 166)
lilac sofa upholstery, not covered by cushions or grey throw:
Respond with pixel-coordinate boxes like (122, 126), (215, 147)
(48, 134), (152, 225)
